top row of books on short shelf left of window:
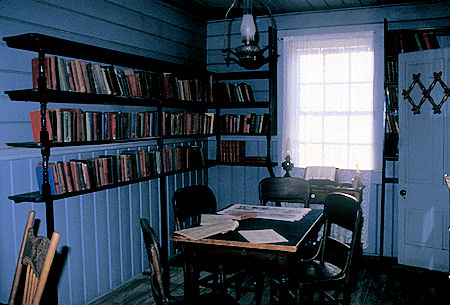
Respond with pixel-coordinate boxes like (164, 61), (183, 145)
(216, 82), (255, 104)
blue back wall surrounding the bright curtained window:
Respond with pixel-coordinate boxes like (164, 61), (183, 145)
(207, 2), (450, 257)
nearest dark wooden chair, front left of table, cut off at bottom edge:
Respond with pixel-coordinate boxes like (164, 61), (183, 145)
(140, 218), (239, 305)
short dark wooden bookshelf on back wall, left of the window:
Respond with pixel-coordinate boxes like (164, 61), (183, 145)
(214, 28), (278, 177)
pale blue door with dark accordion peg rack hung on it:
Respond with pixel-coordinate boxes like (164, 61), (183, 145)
(398, 48), (450, 272)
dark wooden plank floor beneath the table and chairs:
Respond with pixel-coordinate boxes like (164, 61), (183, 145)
(89, 257), (450, 305)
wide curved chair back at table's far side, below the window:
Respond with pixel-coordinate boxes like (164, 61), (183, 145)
(259, 177), (310, 206)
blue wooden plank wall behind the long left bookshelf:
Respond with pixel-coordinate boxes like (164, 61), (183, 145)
(0, 0), (207, 304)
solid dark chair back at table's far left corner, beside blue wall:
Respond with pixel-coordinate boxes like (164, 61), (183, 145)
(172, 185), (217, 230)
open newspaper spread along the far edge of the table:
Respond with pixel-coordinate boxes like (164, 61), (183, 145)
(217, 204), (311, 222)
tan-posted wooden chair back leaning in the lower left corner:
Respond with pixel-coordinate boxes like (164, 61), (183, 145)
(9, 211), (60, 305)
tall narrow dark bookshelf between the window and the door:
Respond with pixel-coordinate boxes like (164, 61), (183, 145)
(380, 19), (449, 256)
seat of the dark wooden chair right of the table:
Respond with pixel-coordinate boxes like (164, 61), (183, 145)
(293, 260), (343, 285)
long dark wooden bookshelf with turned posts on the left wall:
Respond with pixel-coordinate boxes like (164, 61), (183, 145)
(3, 33), (211, 248)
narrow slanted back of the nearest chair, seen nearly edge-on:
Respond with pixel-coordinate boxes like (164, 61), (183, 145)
(140, 218), (169, 305)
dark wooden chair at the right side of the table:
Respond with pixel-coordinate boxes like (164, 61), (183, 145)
(275, 193), (362, 305)
